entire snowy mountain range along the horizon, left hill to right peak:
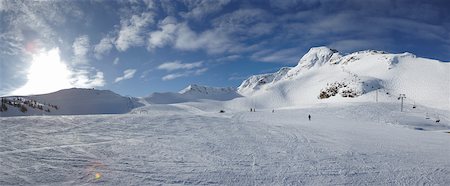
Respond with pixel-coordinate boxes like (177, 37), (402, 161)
(0, 47), (450, 116)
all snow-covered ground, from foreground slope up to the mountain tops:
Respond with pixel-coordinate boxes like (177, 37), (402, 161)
(0, 47), (450, 185)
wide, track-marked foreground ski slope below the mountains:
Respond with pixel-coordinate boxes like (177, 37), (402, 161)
(0, 102), (450, 185)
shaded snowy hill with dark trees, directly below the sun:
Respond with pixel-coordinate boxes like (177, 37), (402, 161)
(0, 88), (142, 116)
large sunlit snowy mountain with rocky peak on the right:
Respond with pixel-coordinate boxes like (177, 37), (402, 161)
(238, 47), (450, 109)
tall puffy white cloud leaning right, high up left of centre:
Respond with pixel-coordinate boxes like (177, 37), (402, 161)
(115, 12), (154, 51)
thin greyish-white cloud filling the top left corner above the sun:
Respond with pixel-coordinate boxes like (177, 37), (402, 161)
(0, 0), (83, 48)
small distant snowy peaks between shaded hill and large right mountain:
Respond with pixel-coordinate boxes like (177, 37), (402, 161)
(144, 84), (241, 104)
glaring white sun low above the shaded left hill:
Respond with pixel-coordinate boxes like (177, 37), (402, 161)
(12, 48), (72, 95)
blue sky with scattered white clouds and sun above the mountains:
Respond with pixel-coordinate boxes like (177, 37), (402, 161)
(0, 0), (450, 96)
